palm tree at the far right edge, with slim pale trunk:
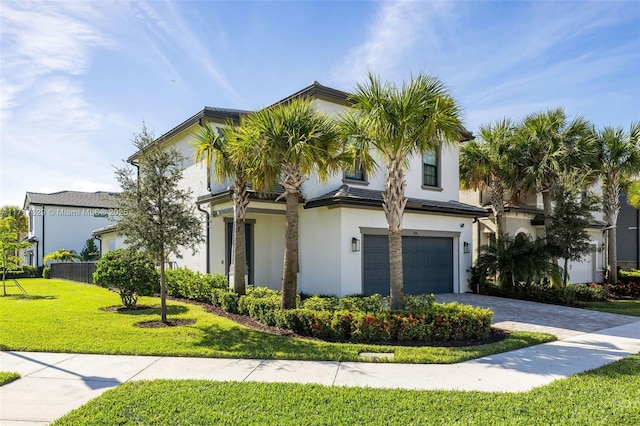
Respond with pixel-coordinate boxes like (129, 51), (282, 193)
(596, 122), (640, 282)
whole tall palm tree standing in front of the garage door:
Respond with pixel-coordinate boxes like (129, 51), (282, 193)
(341, 74), (463, 309)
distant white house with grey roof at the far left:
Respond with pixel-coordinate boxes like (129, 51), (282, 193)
(24, 191), (118, 266)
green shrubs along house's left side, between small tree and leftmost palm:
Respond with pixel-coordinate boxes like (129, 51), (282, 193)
(165, 268), (228, 302)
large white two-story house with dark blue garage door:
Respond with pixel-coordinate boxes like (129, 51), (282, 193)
(122, 82), (487, 296)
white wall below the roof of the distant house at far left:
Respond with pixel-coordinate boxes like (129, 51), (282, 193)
(26, 204), (113, 266)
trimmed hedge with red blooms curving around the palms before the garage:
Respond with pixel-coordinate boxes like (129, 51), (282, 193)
(211, 288), (493, 342)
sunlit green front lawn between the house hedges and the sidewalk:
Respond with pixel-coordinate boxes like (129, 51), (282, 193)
(0, 279), (555, 364)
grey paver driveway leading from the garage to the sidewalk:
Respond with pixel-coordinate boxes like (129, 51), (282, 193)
(436, 293), (640, 340)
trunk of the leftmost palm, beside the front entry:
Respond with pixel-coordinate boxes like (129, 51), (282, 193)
(232, 180), (249, 294)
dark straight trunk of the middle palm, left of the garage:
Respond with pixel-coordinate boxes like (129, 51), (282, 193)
(282, 192), (298, 309)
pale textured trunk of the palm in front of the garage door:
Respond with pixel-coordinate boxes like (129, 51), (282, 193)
(382, 158), (407, 309)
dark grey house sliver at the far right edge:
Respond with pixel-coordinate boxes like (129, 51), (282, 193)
(617, 194), (640, 269)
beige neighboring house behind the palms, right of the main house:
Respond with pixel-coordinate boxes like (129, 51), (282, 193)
(460, 188), (606, 284)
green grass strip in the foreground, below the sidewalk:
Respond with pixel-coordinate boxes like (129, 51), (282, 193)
(53, 354), (640, 426)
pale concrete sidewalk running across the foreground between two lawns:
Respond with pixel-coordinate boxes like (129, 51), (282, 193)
(0, 322), (640, 425)
